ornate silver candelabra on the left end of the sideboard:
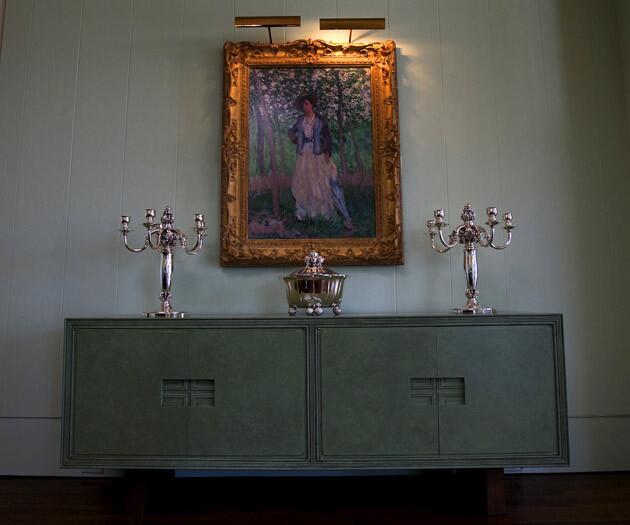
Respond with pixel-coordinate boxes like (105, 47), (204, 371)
(120, 207), (207, 318)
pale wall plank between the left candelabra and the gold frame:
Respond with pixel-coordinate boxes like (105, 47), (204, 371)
(174, 0), (248, 313)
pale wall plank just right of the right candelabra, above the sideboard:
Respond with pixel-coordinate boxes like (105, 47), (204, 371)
(489, 0), (557, 311)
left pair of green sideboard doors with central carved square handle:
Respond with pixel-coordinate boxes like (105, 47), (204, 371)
(64, 323), (308, 467)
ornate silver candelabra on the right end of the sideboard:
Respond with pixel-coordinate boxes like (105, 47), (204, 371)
(427, 204), (514, 314)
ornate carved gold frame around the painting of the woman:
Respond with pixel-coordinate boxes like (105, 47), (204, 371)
(220, 40), (403, 266)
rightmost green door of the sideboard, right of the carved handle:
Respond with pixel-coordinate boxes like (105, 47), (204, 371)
(437, 324), (560, 465)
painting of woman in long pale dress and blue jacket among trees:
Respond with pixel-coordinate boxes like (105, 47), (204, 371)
(248, 67), (376, 239)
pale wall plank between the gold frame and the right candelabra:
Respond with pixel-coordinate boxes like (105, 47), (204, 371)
(389, 0), (454, 312)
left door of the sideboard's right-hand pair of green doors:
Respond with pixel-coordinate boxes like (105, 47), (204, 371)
(318, 326), (438, 465)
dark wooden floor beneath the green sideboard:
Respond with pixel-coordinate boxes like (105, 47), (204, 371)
(0, 472), (630, 525)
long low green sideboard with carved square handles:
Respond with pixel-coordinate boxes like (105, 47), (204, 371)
(62, 314), (568, 470)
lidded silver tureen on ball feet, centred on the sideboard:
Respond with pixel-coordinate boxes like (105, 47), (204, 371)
(283, 251), (347, 316)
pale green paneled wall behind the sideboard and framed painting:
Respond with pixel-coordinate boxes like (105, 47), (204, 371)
(0, 0), (630, 475)
